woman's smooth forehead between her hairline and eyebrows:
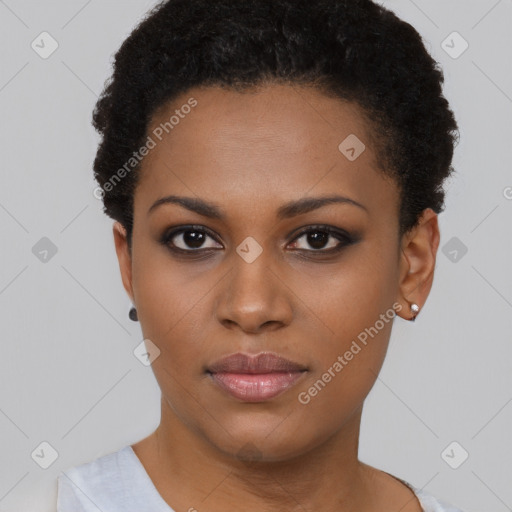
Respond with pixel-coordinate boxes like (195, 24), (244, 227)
(136, 85), (396, 218)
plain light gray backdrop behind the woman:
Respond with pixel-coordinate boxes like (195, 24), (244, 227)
(0, 0), (512, 512)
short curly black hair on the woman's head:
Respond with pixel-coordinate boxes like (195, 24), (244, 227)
(93, 0), (459, 245)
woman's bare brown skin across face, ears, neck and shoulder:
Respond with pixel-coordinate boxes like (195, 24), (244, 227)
(113, 85), (440, 512)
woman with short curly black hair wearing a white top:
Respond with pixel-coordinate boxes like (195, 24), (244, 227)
(58, 0), (464, 512)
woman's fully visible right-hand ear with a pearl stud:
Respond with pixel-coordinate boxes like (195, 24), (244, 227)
(398, 208), (440, 320)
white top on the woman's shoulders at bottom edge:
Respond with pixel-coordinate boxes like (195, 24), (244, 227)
(57, 445), (461, 512)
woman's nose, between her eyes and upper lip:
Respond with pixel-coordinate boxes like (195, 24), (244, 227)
(212, 246), (293, 333)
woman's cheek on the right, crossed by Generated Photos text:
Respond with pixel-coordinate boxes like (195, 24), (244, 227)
(288, 243), (399, 412)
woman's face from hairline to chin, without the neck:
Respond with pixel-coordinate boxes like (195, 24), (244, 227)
(115, 85), (432, 460)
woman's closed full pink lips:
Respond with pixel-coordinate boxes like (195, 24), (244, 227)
(208, 352), (306, 402)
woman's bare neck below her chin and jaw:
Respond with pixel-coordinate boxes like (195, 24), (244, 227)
(145, 398), (371, 512)
